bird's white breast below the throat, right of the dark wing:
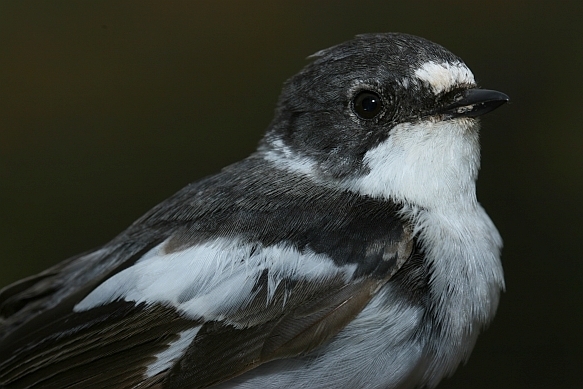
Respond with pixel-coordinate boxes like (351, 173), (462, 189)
(409, 203), (504, 386)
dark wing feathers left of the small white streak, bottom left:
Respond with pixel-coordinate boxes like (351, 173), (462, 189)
(0, 302), (200, 388)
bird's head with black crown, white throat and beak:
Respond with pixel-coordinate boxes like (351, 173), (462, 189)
(260, 33), (508, 207)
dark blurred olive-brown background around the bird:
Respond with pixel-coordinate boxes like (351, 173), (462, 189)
(0, 0), (583, 389)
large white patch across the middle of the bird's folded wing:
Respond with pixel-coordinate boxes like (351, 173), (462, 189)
(75, 238), (356, 324)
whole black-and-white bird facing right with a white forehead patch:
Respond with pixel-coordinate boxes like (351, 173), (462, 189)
(0, 33), (509, 389)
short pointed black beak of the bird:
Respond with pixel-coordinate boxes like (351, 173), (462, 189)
(439, 89), (510, 118)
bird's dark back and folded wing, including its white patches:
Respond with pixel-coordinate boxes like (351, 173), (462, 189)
(0, 158), (415, 387)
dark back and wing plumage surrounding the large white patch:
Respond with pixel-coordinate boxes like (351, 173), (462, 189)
(0, 161), (414, 388)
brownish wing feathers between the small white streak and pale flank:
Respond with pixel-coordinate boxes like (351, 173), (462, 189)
(164, 270), (406, 389)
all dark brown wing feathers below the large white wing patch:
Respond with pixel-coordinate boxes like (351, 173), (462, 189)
(0, 233), (412, 389)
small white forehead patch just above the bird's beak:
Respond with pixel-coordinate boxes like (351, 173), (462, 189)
(415, 61), (476, 94)
